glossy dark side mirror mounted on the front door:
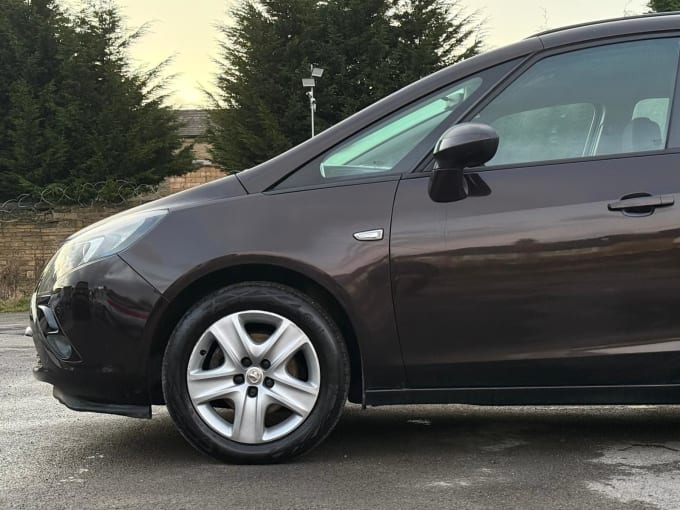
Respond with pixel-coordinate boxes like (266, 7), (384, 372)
(429, 122), (499, 202)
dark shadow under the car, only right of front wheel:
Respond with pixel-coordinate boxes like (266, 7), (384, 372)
(318, 405), (680, 456)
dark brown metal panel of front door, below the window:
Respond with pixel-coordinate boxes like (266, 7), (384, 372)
(391, 154), (680, 388)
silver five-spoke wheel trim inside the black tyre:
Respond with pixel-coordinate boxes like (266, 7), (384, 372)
(187, 310), (321, 444)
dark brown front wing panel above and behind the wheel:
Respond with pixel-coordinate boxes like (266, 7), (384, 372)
(122, 178), (404, 388)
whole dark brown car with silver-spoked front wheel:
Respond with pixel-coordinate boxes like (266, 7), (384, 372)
(31, 15), (680, 462)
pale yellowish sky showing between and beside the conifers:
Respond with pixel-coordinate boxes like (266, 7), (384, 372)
(110, 0), (647, 108)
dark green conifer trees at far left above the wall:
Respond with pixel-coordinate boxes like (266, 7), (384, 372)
(0, 0), (191, 199)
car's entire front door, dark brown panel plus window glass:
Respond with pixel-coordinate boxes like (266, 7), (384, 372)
(390, 38), (680, 388)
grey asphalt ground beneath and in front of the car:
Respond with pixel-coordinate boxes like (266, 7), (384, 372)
(0, 314), (680, 510)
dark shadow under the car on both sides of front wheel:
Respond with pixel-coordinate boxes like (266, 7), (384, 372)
(83, 405), (680, 466)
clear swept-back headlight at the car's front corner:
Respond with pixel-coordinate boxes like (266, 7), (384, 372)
(50, 210), (168, 276)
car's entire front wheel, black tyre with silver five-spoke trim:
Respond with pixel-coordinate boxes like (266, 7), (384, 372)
(163, 282), (349, 463)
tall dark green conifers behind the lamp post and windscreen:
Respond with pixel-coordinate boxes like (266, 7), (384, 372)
(209, 0), (481, 171)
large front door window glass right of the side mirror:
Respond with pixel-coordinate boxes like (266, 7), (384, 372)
(475, 39), (680, 166)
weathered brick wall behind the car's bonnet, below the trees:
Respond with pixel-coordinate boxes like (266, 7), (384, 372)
(0, 167), (225, 299)
